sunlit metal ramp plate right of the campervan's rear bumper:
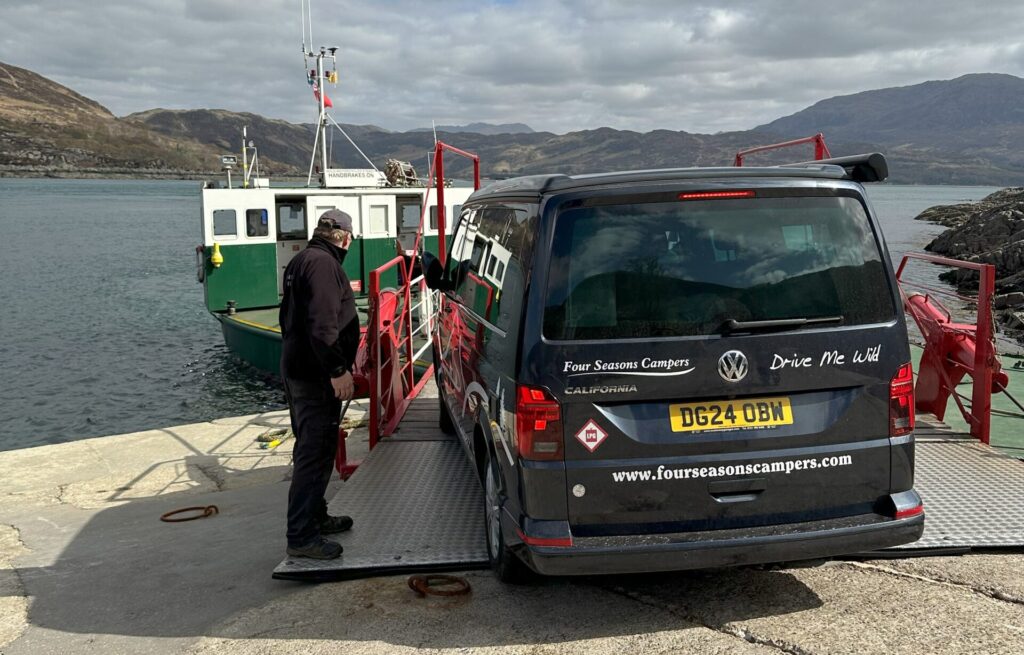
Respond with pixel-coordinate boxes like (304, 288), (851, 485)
(891, 439), (1024, 550)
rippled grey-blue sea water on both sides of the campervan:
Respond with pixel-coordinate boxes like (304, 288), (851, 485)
(0, 179), (995, 449)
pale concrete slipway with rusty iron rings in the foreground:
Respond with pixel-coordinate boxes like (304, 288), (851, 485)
(0, 386), (1024, 655)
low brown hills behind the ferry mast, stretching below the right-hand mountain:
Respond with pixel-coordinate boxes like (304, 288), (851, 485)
(129, 110), (1024, 185)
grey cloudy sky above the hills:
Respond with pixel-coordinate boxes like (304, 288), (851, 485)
(0, 0), (1024, 133)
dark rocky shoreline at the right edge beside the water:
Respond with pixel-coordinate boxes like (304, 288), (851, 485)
(916, 186), (1024, 335)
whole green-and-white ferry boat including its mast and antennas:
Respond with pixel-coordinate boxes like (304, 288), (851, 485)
(196, 39), (473, 375)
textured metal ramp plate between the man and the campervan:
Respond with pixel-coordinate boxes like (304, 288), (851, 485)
(273, 438), (487, 581)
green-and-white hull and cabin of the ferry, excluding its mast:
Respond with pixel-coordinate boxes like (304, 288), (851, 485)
(198, 179), (473, 374)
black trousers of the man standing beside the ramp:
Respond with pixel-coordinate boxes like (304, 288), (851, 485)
(284, 377), (341, 548)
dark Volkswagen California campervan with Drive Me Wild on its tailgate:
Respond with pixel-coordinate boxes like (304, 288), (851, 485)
(426, 155), (924, 579)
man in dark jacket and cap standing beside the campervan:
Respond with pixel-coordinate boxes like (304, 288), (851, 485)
(281, 210), (359, 560)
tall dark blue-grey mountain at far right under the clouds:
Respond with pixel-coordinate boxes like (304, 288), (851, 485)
(755, 73), (1024, 171)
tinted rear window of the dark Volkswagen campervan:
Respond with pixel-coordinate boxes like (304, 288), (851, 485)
(544, 195), (895, 340)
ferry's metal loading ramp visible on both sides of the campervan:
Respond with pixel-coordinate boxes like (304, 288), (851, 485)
(273, 383), (1024, 581)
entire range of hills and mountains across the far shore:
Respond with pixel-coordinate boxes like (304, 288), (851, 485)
(6, 64), (1024, 185)
